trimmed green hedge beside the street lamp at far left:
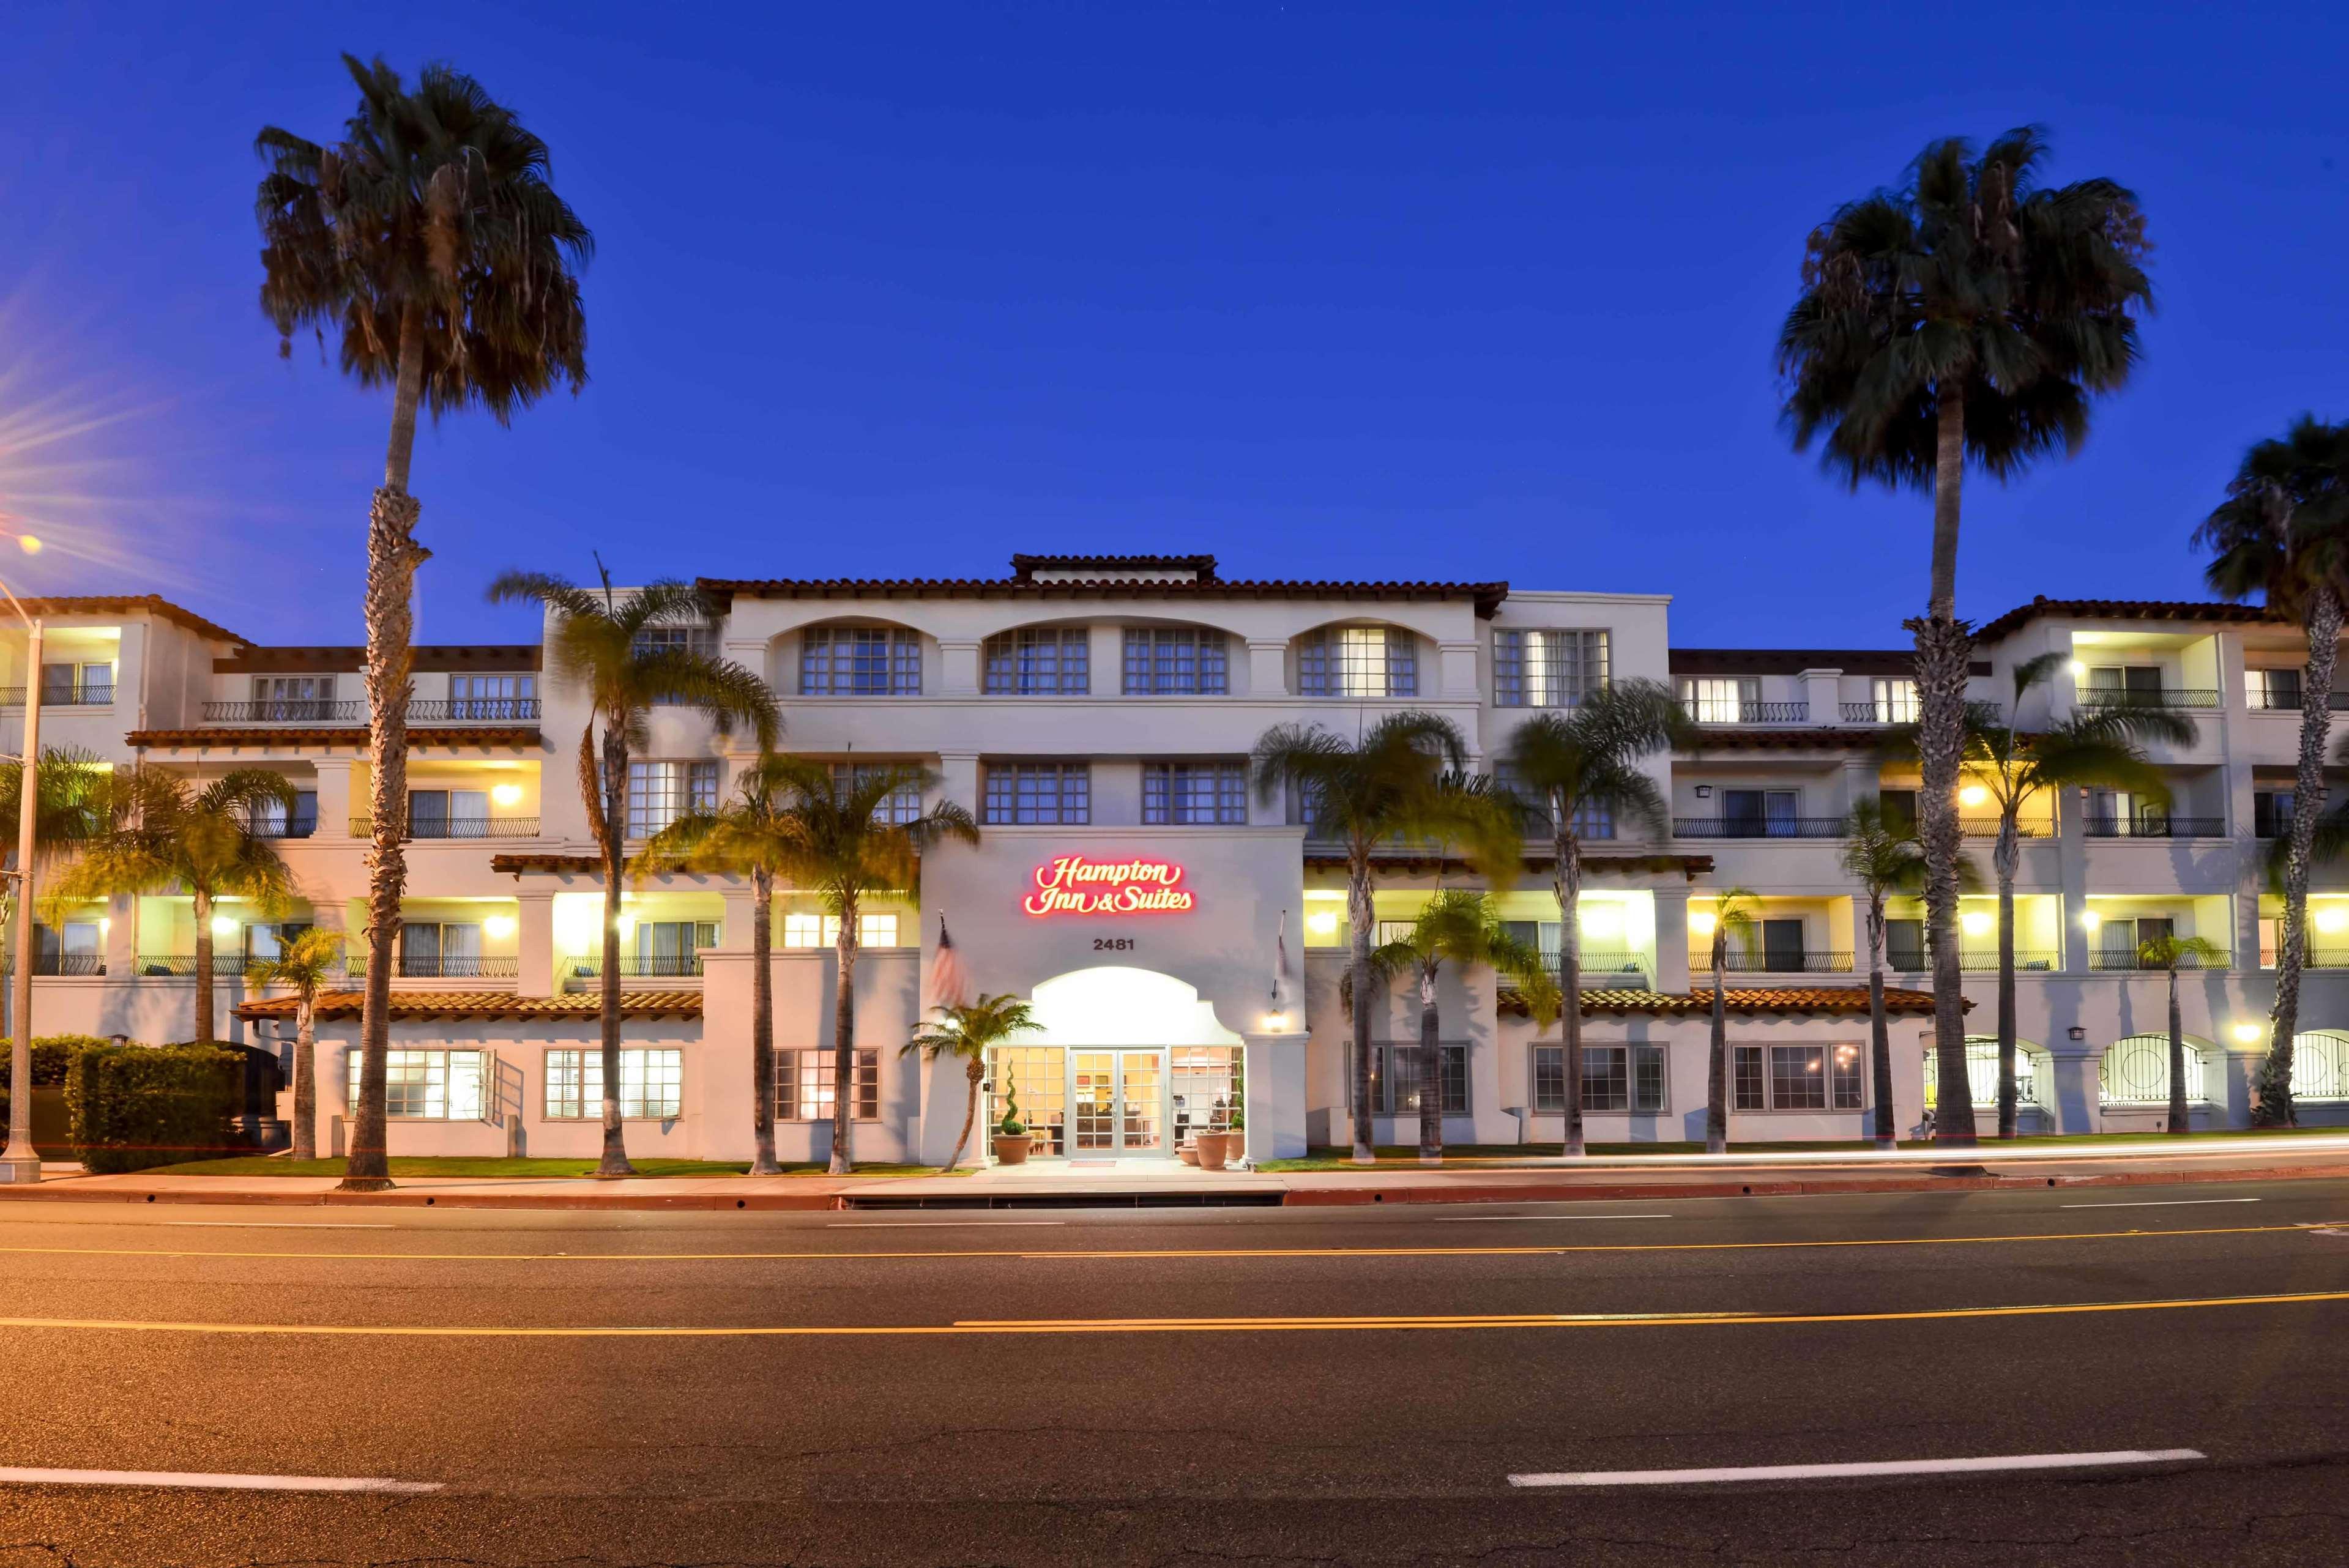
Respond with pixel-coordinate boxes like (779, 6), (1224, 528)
(65, 1042), (244, 1172)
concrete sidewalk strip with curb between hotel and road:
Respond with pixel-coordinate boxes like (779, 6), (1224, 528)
(0, 1136), (2349, 1211)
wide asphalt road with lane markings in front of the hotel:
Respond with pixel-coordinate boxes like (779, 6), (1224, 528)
(0, 1183), (2349, 1568)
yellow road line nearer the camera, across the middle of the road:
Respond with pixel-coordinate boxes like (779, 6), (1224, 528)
(0, 1291), (2349, 1340)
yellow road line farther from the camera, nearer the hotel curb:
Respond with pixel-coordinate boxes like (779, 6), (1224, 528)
(0, 1221), (2349, 1263)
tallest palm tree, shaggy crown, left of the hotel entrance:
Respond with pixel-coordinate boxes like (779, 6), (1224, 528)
(254, 54), (594, 1190)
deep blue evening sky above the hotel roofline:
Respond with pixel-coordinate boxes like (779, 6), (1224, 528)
(0, 0), (2349, 645)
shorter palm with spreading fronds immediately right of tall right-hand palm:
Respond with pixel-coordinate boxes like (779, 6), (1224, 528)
(1935, 653), (2194, 1139)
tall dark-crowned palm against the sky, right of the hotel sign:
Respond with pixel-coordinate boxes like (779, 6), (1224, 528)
(1778, 127), (2152, 1143)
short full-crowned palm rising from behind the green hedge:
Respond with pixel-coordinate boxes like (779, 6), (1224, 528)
(47, 768), (294, 1044)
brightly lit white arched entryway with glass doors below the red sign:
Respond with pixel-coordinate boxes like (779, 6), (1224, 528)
(986, 965), (1245, 1159)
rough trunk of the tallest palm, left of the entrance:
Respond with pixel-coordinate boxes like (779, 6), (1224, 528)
(343, 303), (432, 1192)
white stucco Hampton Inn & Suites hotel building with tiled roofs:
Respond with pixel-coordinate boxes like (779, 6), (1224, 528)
(0, 556), (2349, 1162)
